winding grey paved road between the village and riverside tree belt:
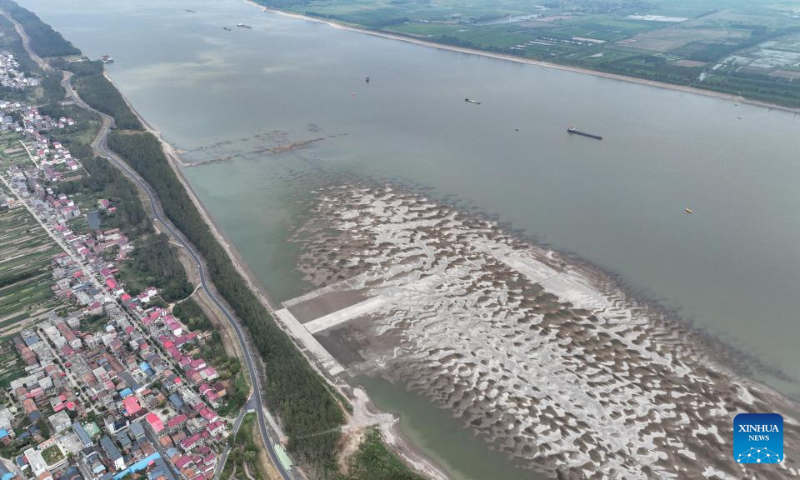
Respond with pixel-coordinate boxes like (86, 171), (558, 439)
(62, 72), (292, 480)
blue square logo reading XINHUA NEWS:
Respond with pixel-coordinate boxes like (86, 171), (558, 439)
(733, 413), (783, 463)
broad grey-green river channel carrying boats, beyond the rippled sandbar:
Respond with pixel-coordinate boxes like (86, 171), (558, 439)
(20, 0), (800, 478)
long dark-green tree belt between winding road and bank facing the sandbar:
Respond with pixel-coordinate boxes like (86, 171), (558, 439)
(108, 131), (344, 477)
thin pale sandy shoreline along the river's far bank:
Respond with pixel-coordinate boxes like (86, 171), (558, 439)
(245, 0), (800, 114)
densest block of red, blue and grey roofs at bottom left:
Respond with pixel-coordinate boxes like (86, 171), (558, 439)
(5, 293), (228, 480)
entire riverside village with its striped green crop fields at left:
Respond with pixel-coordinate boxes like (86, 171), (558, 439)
(0, 45), (239, 480)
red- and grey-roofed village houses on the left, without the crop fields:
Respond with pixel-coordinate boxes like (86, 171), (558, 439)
(0, 63), (234, 480)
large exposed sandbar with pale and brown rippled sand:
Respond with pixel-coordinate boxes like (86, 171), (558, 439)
(295, 185), (798, 478)
